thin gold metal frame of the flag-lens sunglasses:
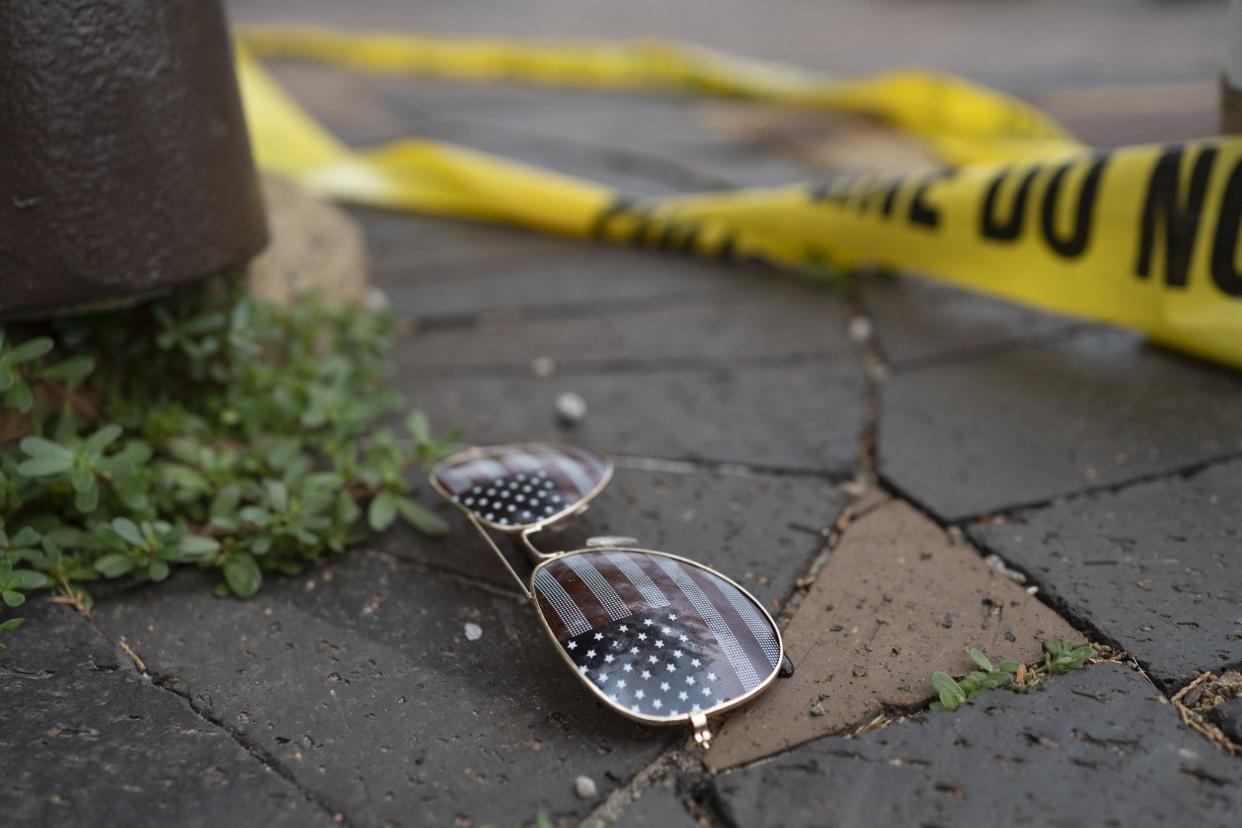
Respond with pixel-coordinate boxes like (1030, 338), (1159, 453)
(427, 442), (785, 749)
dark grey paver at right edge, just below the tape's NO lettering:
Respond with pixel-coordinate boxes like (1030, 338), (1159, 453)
(879, 331), (1242, 520)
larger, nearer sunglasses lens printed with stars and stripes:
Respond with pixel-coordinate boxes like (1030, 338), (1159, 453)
(534, 550), (781, 720)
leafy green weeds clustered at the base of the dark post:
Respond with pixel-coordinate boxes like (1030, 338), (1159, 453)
(0, 282), (457, 633)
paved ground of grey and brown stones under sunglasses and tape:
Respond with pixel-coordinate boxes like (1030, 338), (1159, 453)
(0, 0), (1242, 828)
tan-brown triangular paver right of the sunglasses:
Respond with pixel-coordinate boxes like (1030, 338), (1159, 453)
(707, 491), (1081, 771)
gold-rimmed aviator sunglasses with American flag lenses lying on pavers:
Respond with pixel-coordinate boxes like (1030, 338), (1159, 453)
(430, 443), (794, 747)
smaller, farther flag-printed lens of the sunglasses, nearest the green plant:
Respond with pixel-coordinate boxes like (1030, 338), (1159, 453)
(432, 444), (609, 529)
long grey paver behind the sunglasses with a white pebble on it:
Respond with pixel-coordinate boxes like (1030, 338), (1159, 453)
(412, 360), (866, 477)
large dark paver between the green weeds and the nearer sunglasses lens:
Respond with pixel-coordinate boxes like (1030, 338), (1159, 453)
(96, 550), (681, 826)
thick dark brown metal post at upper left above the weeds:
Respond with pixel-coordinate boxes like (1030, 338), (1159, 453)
(0, 0), (267, 315)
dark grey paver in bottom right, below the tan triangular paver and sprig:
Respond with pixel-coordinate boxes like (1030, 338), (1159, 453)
(715, 664), (1242, 828)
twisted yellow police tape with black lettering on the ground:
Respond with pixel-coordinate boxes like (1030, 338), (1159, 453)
(237, 27), (1242, 367)
